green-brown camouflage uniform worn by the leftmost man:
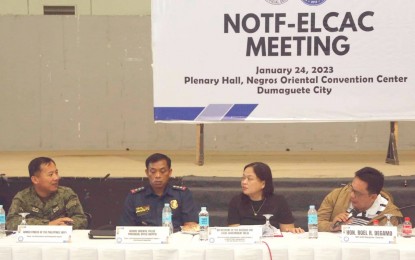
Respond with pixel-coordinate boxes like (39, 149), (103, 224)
(6, 186), (88, 230)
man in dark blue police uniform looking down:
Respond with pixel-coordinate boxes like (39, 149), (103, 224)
(119, 153), (198, 231)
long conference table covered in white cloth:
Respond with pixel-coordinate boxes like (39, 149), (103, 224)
(0, 230), (415, 260)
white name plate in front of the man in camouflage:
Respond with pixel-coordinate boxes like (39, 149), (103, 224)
(17, 225), (72, 243)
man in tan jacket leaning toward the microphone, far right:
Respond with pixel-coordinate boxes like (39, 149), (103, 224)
(318, 167), (402, 232)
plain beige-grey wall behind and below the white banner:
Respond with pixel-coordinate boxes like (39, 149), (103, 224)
(0, 15), (415, 151)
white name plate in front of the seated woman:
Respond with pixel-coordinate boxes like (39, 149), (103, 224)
(209, 225), (262, 244)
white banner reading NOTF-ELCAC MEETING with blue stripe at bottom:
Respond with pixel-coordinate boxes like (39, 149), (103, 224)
(152, 0), (415, 123)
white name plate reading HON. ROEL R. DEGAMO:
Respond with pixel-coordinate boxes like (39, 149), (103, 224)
(342, 225), (398, 244)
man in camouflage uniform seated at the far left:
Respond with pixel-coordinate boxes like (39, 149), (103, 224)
(6, 157), (88, 230)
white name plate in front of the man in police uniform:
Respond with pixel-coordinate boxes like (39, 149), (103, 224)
(115, 227), (170, 244)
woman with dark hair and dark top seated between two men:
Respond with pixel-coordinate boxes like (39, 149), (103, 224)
(228, 162), (304, 233)
